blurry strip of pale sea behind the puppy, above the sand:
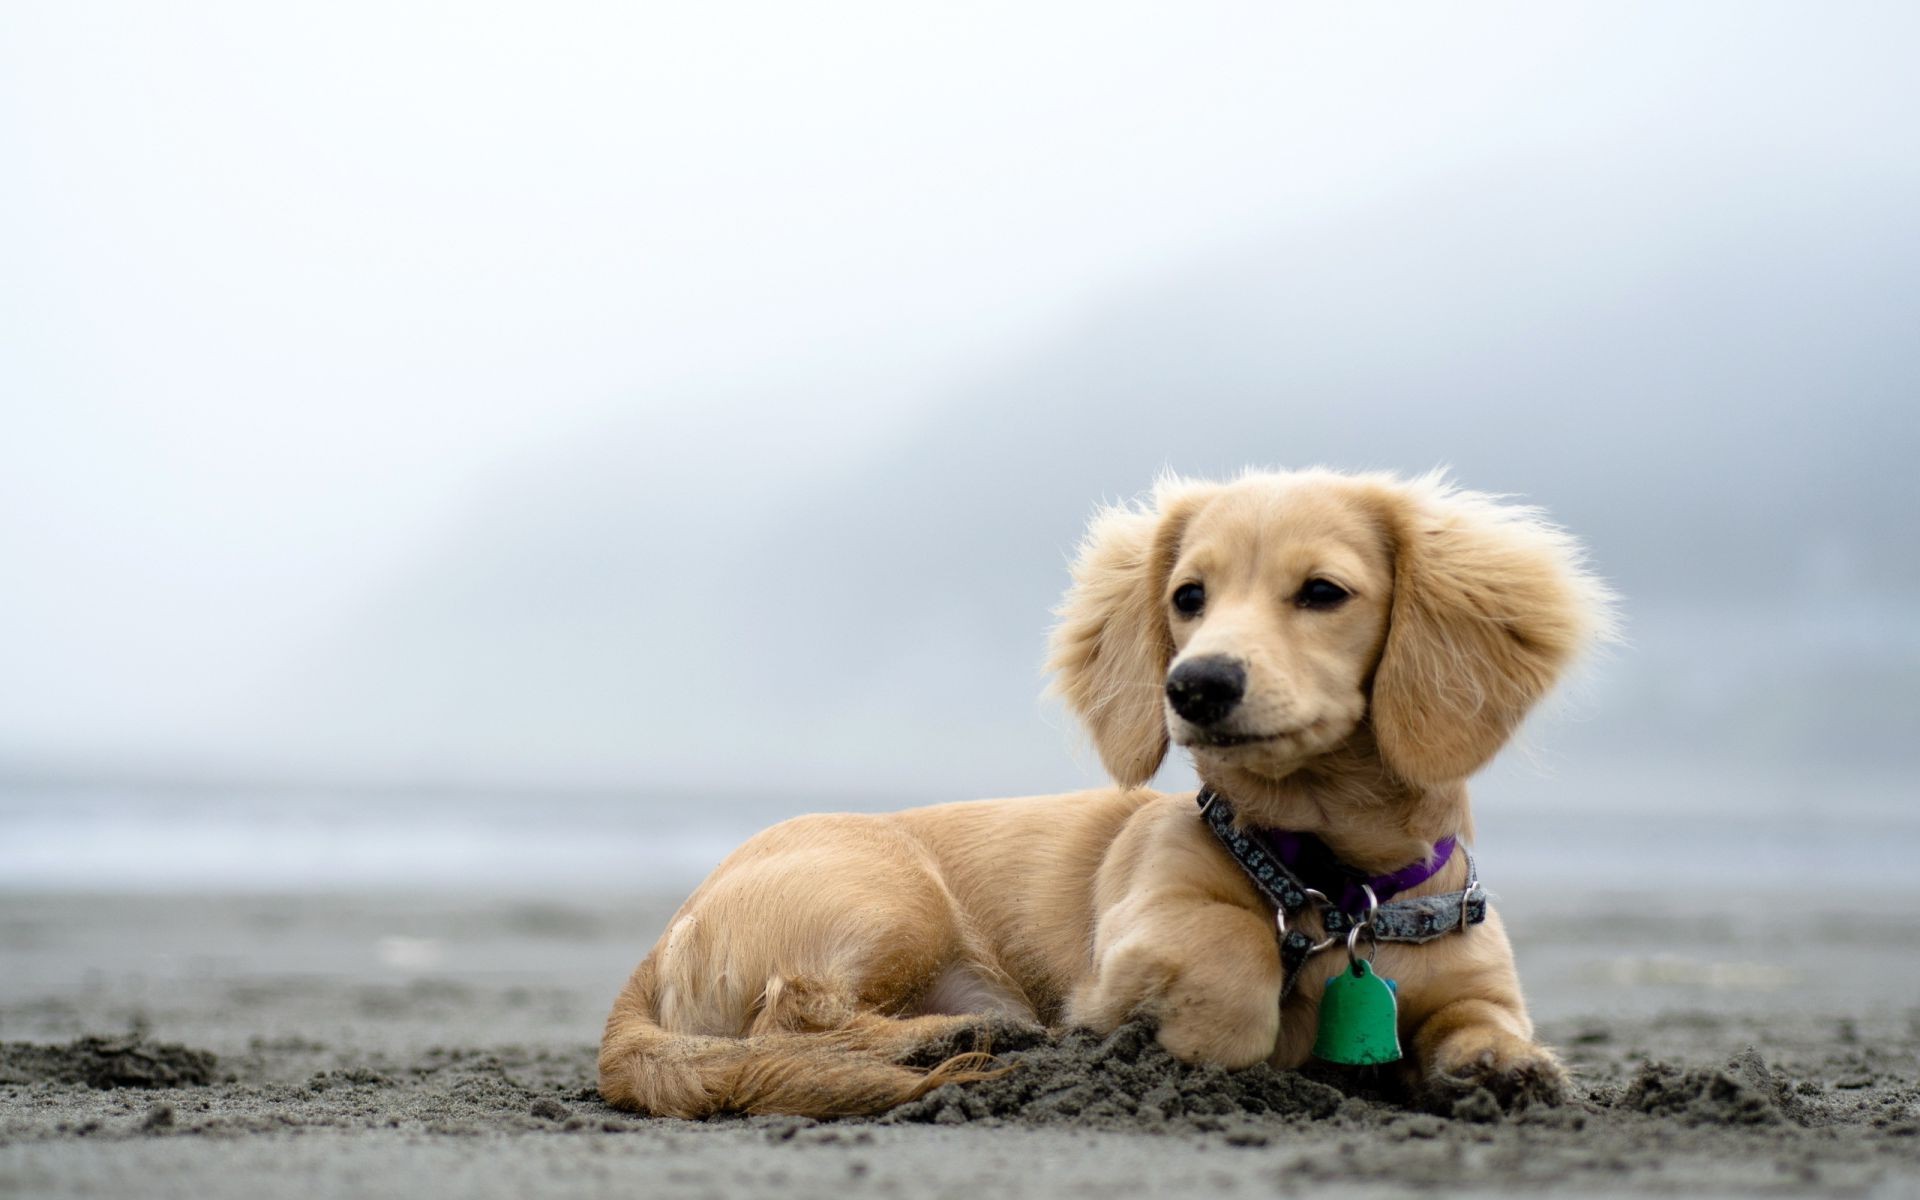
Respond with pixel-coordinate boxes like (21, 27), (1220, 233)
(0, 760), (1920, 895)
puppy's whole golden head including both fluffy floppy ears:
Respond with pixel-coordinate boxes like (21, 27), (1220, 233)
(1048, 470), (1609, 791)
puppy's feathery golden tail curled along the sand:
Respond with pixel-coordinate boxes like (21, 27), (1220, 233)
(599, 956), (1006, 1117)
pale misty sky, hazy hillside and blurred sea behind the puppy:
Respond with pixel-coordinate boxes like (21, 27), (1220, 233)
(0, 0), (1920, 898)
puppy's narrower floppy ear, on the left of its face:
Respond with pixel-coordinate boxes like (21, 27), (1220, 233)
(1046, 476), (1217, 787)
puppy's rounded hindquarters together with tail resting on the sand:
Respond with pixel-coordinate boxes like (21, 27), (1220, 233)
(601, 816), (1035, 1116)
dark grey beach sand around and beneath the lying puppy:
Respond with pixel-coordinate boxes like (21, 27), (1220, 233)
(0, 883), (1920, 1198)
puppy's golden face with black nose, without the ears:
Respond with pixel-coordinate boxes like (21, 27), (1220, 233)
(1162, 478), (1394, 776)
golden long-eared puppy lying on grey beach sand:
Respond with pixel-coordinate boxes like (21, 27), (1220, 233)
(599, 468), (1613, 1117)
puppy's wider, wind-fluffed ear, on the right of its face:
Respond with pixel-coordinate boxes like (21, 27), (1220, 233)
(1373, 474), (1615, 787)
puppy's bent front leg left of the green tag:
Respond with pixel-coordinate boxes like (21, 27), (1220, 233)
(1068, 895), (1281, 1068)
